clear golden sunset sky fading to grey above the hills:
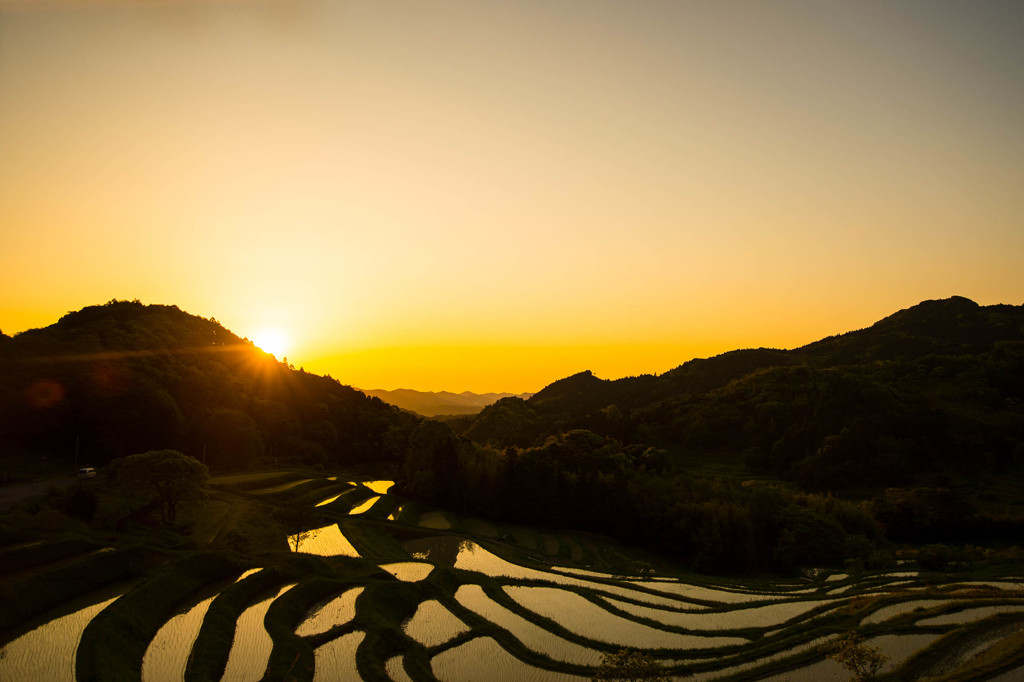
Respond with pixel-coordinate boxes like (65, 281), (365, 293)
(0, 0), (1024, 392)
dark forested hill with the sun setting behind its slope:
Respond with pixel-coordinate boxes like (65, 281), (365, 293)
(0, 301), (419, 470)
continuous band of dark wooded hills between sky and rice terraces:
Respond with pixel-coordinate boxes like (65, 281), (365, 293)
(0, 298), (1024, 572)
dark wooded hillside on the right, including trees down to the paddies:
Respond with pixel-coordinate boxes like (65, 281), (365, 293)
(407, 298), (1024, 571)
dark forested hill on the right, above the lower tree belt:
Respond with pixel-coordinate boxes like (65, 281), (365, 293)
(454, 297), (1024, 489)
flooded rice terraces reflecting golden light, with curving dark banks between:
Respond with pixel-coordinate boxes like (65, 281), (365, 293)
(0, 479), (1024, 682)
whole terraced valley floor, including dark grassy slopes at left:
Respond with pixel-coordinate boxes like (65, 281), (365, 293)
(0, 471), (1024, 682)
